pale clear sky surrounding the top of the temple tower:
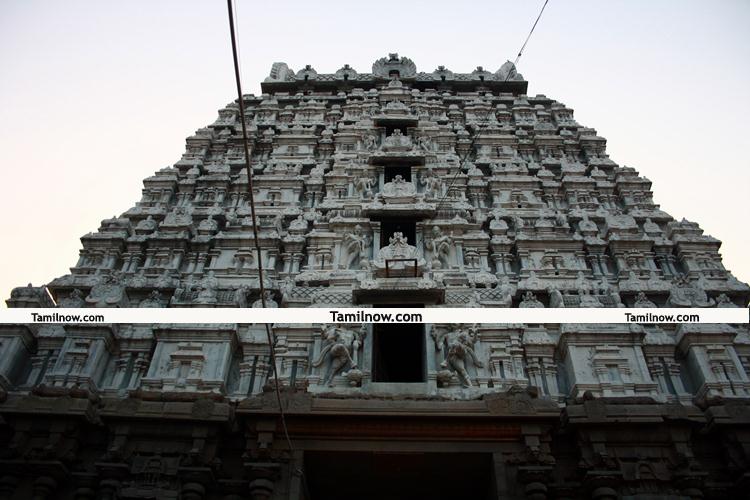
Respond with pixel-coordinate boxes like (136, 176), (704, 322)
(0, 0), (750, 306)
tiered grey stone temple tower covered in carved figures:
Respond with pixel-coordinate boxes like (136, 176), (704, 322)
(0, 54), (750, 500)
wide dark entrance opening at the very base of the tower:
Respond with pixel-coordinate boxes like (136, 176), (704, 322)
(305, 452), (497, 500)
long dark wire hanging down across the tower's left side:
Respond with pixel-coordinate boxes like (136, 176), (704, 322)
(227, 0), (304, 482)
